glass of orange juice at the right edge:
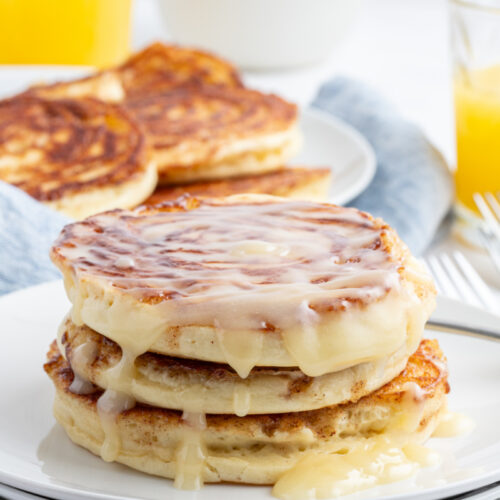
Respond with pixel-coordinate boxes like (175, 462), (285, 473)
(450, 0), (500, 210)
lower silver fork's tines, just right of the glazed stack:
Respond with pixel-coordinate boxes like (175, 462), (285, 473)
(424, 250), (500, 314)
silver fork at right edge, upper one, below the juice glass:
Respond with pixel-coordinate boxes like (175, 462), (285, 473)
(472, 193), (500, 272)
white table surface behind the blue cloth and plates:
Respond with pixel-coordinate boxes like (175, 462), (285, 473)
(132, 0), (500, 297)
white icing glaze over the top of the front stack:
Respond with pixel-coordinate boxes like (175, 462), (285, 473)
(55, 202), (399, 329)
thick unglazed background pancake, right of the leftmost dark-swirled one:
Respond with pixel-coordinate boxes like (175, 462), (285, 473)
(124, 86), (301, 184)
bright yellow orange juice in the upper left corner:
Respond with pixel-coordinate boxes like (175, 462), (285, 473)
(0, 0), (131, 67)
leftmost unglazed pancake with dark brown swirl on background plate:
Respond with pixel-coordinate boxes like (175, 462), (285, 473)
(0, 96), (157, 219)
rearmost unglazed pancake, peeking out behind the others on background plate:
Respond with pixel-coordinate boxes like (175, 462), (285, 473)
(29, 43), (243, 102)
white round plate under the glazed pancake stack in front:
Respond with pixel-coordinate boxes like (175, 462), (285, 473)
(0, 281), (500, 500)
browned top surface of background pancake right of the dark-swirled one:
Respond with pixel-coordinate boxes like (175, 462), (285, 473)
(125, 86), (297, 154)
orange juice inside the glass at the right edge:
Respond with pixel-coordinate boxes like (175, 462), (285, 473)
(455, 65), (500, 209)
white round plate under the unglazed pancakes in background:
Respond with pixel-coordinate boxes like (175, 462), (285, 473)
(0, 66), (376, 205)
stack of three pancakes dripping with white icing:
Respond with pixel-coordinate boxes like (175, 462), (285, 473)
(45, 195), (448, 498)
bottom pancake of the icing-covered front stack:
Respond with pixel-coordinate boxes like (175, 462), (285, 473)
(45, 340), (449, 486)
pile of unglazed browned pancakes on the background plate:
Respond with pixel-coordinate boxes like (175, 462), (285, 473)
(0, 43), (330, 218)
